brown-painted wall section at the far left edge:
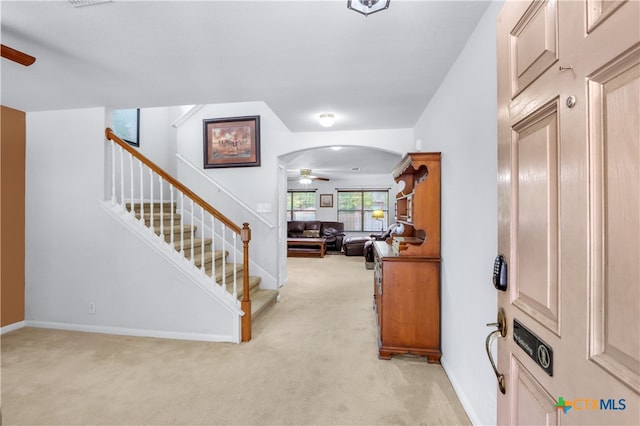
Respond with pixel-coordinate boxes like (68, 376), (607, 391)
(0, 106), (26, 327)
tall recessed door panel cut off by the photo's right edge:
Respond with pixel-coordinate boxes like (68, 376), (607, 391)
(589, 46), (640, 392)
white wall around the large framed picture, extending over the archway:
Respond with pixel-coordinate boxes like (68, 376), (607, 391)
(177, 102), (413, 288)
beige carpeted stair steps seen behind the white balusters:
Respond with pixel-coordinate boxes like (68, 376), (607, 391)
(125, 202), (278, 321)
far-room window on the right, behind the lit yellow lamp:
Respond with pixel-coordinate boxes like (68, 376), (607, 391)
(338, 190), (389, 232)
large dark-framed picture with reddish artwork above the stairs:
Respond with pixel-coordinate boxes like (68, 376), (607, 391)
(203, 115), (260, 169)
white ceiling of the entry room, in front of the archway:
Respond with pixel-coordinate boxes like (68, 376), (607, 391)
(0, 0), (488, 178)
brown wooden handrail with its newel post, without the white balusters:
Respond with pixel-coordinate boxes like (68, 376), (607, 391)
(104, 127), (251, 342)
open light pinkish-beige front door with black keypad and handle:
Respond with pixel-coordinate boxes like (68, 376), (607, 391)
(497, 0), (640, 425)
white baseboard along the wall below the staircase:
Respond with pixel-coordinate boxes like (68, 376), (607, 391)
(23, 321), (235, 343)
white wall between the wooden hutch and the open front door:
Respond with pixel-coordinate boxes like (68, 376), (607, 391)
(415, 2), (502, 425)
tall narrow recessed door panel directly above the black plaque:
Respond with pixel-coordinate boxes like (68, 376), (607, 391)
(512, 100), (560, 334)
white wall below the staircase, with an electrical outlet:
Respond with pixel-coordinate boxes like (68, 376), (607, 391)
(25, 108), (240, 340)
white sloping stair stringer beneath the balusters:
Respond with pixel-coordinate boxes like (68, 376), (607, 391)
(98, 200), (244, 343)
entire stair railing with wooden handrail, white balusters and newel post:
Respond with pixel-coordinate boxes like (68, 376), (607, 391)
(105, 128), (251, 342)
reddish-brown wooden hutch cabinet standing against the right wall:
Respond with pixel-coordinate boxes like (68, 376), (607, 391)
(374, 153), (441, 362)
